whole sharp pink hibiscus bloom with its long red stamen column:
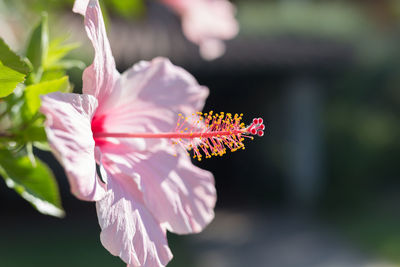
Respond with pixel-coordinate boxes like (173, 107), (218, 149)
(41, 0), (264, 266)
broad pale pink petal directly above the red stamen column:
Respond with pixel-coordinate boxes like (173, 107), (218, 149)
(96, 58), (208, 139)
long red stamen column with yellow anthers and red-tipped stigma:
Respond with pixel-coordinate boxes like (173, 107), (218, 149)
(93, 111), (265, 161)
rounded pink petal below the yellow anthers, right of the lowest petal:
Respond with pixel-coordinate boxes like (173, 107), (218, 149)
(104, 150), (216, 234)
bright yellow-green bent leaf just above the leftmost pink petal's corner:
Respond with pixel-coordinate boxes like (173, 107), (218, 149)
(25, 76), (70, 114)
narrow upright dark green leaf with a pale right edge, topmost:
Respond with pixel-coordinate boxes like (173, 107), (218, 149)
(26, 13), (49, 74)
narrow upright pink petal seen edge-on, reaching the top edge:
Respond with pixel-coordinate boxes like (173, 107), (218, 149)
(82, 0), (119, 108)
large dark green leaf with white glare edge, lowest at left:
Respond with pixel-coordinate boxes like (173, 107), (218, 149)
(0, 150), (65, 217)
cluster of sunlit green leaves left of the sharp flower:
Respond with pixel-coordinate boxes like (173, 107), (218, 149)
(0, 13), (84, 217)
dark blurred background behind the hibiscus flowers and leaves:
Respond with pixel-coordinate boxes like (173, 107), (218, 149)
(0, 0), (400, 267)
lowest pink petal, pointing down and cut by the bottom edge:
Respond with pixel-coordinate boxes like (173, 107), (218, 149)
(96, 173), (172, 267)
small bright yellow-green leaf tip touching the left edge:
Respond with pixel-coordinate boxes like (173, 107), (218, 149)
(0, 61), (25, 97)
